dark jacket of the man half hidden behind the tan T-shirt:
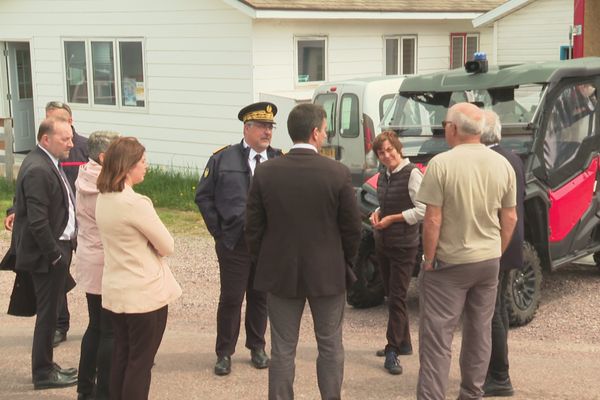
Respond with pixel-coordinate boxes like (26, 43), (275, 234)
(491, 145), (525, 271)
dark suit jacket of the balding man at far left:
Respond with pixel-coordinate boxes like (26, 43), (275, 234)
(9, 146), (69, 272)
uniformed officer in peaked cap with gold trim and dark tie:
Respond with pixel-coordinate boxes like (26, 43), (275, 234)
(196, 102), (282, 375)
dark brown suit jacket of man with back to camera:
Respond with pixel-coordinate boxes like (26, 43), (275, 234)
(245, 149), (361, 297)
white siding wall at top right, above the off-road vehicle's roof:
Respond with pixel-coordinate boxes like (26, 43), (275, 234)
(497, 0), (573, 64)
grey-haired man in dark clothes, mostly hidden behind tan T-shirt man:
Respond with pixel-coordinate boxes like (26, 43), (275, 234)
(481, 110), (525, 397)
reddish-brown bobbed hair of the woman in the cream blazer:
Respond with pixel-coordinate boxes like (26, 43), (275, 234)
(97, 136), (146, 193)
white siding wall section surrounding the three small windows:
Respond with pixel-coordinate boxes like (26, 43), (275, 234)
(253, 20), (492, 148)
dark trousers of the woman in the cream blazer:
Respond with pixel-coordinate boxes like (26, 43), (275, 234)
(110, 306), (168, 400)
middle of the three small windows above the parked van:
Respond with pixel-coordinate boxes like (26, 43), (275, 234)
(384, 36), (417, 75)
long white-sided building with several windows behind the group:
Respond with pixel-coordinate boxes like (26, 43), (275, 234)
(0, 0), (508, 169)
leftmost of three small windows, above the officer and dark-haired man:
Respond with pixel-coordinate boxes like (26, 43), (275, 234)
(296, 38), (326, 83)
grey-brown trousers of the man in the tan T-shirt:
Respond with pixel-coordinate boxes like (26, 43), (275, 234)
(417, 259), (499, 400)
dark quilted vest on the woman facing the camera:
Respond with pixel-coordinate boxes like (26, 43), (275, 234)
(376, 163), (419, 247)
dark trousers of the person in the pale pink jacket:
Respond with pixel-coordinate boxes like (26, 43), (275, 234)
(77, 293), (113, 400)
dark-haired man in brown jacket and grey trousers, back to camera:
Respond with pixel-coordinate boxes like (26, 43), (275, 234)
(245, 104), (361, 399)
